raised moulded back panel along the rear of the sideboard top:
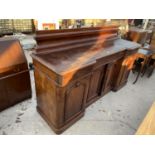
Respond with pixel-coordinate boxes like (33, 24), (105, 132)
(36, 26), (118, 54)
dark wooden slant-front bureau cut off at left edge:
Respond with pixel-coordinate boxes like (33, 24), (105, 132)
(0, 38), (31, 111)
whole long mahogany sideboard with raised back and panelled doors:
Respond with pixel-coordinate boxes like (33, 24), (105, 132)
(32, 26), (140, 134)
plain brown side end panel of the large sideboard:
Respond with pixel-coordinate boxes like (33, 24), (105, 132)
(34, 68), (58, 127)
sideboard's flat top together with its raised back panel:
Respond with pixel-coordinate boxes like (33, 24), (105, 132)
(32, 26), (140, 76)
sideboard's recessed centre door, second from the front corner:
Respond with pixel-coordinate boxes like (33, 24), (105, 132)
(87, 66), (105, 102)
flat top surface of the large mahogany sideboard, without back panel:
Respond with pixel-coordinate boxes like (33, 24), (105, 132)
(32, 39), (140, 75)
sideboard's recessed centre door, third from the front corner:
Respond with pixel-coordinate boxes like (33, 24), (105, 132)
(102, 62), (115, 94)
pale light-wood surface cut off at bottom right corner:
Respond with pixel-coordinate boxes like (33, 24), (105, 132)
(136, 102), (155, 135)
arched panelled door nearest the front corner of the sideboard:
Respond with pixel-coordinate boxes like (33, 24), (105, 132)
(64, 77), (90, 121)
